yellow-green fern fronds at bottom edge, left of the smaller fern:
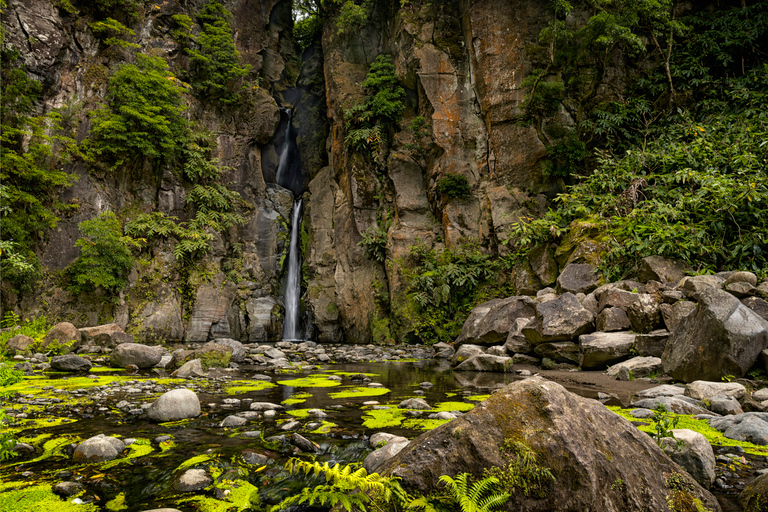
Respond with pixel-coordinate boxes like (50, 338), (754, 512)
(270, 458), (405, 512)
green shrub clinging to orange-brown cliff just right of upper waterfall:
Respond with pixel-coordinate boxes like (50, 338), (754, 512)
(344, 55), (405, 156)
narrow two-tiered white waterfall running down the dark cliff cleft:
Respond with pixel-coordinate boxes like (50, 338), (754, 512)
(275, 110), (304, 340)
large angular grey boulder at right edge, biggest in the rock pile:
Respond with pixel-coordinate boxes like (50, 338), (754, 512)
(661, 287), (768, 382)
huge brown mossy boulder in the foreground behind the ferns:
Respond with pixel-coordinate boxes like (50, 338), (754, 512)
(379, 377), (720, 512)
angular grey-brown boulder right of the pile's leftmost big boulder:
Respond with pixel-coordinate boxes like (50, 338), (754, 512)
(522, 293), (595, 345)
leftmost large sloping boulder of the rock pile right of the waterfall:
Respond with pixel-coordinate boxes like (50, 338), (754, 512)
(454, 296), (536, 347)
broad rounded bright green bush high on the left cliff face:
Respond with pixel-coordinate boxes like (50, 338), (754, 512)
(88, 54), (189, 166)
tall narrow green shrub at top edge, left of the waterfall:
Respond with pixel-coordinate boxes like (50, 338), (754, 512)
(187, 0), (251, 104)
